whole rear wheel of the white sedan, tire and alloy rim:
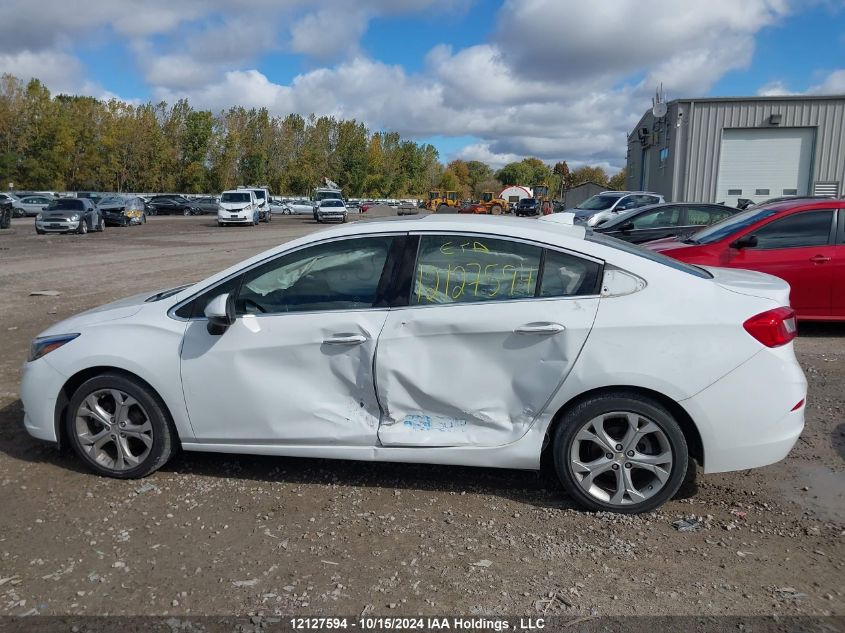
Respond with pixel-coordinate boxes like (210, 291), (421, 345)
(553, 393), (689, 514)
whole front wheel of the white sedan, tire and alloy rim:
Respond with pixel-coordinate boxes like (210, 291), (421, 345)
(65, 374), (178, 479)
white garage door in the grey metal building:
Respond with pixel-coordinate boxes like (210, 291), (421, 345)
(716, 127), (815, 205)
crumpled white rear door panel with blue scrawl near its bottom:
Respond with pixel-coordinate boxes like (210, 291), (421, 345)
(376, 299), (599, 446)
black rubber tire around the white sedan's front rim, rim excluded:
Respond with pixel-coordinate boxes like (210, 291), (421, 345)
(64, 373), (179, 479)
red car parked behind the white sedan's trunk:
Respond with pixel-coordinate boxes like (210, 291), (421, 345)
(643, 198), (845, 321)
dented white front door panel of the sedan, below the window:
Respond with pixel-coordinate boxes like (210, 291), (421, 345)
(182, 311), (387, 446)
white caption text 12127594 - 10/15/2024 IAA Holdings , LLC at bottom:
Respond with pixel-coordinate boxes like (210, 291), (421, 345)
(289, 616), (546, 632)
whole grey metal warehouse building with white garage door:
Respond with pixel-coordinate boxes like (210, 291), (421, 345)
(626, 95), (845, 205)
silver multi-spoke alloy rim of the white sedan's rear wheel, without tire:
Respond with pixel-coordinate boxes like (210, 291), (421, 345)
(569, 411), (674, 506)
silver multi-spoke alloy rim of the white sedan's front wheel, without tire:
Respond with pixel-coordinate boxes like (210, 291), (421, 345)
(74, 389), (153, 471)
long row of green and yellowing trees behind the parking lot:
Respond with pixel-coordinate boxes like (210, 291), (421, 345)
(0, 74), (624, 198)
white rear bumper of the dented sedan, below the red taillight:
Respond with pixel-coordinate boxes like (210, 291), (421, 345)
(679, 344), (807, 473)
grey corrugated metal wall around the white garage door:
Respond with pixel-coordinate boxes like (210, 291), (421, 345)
(627, 97), (845, 202)
